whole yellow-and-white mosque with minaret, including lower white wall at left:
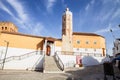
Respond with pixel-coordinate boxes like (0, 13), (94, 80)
(0, 8), (106, 69)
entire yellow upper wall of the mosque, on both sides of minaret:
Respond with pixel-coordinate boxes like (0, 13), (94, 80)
(0, 32), (106, 50)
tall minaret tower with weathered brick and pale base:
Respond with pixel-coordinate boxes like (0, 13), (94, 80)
(62, 8), (73, 52)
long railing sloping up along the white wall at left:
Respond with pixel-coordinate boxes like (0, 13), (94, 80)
(0, 51), (43, 64)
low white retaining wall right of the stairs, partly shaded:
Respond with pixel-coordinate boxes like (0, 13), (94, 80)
(59, 55), (107, 67)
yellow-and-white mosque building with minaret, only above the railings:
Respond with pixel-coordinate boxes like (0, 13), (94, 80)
(0, 8), (106, 69)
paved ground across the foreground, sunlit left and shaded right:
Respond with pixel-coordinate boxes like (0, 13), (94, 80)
(0, 65), (120, 80)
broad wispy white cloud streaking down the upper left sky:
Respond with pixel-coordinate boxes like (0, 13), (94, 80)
(0, 0), (47, 35)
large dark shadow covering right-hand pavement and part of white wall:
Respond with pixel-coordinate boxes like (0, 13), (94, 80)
(64, 56), (112, 80)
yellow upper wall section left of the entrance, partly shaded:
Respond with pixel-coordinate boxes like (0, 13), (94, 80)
(0, 33), (43, 50)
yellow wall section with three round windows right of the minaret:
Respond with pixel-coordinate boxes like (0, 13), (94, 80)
(73, 35), (105, 48)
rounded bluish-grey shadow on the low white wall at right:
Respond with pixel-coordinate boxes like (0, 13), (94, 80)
(82, 56), (100, 66)
